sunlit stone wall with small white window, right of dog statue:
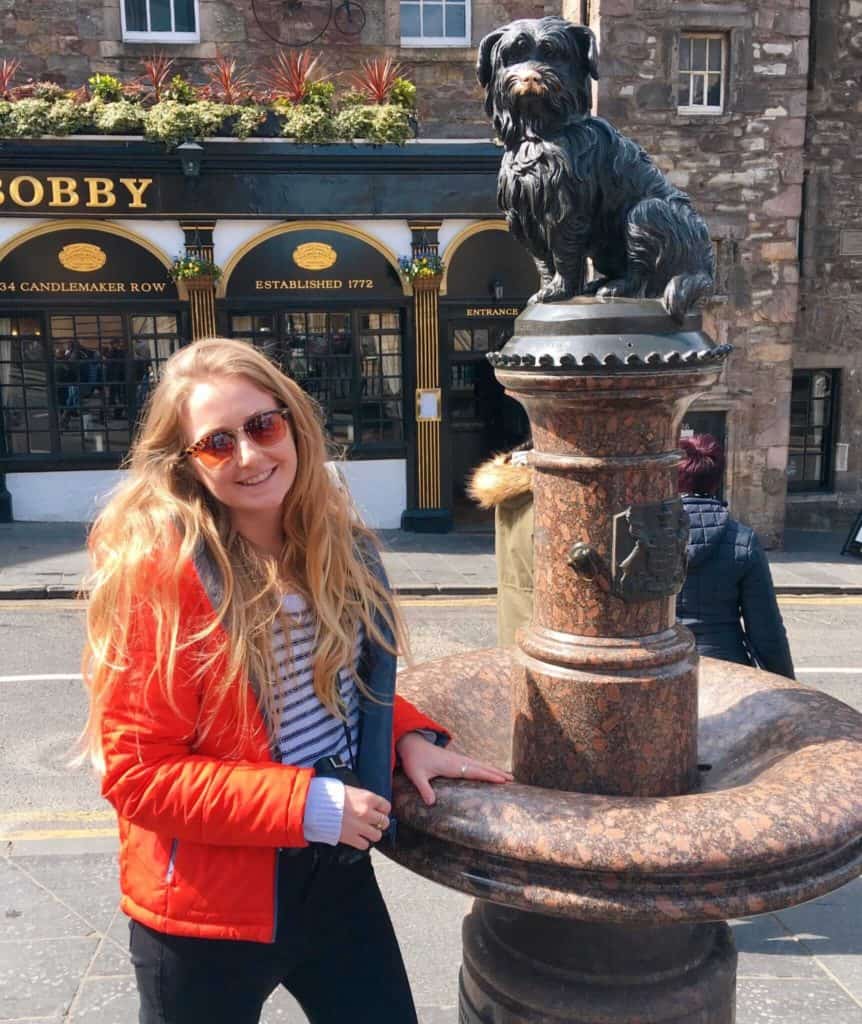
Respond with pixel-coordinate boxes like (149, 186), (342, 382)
(591, 0), (809, 545)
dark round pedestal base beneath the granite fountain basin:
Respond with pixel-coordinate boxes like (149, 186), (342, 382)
(459, 900), (736, 1024)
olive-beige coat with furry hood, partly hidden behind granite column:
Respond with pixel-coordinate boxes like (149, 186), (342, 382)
(469, 454), (532, 647)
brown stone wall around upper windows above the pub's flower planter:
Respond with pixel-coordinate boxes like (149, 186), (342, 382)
(0, 0), (561, 138)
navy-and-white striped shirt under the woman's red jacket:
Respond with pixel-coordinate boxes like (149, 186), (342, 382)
(272, 594), (362, 767)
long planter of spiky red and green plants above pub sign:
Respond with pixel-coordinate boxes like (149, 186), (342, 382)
(0, 50), (417, 148)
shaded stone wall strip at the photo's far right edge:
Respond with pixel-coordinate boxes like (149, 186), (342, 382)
(788, 0), (862, 528)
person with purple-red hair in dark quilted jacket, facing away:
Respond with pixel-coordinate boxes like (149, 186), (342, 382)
(677, 434), (794, 679)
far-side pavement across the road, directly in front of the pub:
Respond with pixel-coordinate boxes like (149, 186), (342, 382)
(0, 522), (862, 598)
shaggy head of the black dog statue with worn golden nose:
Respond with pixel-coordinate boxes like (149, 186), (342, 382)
(476, 17), (599, 142)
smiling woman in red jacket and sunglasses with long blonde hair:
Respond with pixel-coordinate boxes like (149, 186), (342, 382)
(84, 339), (511, 1024)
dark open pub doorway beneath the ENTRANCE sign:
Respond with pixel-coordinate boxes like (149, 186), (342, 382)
(446, 318), (529, 529)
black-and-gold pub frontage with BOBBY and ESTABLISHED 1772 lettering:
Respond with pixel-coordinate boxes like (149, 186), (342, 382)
(0, 138), (537, 531)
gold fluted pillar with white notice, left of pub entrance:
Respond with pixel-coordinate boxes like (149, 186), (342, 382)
(413, 276), (442, 509)
